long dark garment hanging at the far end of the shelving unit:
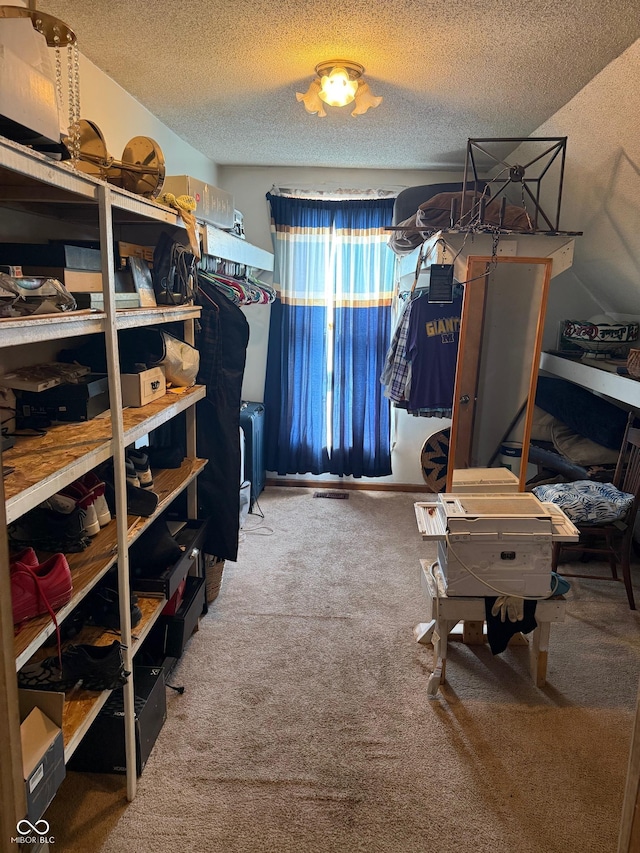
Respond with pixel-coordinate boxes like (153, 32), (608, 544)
(196, 278), (249, 560)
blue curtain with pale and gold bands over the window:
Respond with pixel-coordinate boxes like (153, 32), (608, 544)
(265, 193), (394, 477)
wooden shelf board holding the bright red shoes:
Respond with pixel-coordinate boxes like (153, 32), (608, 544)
(14, 459), (207, 670)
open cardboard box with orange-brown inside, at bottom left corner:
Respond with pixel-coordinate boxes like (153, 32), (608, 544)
(18, 690), (66, 823)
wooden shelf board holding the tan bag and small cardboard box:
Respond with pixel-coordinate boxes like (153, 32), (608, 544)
(3, 385), (205, 524)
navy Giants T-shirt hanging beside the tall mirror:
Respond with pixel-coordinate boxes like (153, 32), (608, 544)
(407, 294), (462, 410)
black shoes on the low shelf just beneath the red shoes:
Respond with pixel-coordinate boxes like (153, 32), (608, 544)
(18, 640), (130, 691)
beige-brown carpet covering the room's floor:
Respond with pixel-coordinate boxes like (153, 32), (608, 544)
(46, 487), (640, 853)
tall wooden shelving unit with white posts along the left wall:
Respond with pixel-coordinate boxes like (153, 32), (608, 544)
(0, 128), (211, 827)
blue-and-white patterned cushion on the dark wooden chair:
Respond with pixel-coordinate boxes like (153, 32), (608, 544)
(532, 480), (633, 524)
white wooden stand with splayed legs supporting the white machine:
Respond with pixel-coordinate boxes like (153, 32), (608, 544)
(414, 560), (566, 699)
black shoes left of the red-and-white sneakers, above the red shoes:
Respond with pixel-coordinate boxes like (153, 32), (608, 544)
(7, 504), (89, 554)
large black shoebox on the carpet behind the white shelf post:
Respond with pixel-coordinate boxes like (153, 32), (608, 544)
(69, 666), (167, 776)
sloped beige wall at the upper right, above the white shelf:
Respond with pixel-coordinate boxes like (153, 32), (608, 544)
(516, 40), (640, 330)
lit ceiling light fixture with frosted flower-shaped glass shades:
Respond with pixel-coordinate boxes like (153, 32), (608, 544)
(296, 59), (382, 118)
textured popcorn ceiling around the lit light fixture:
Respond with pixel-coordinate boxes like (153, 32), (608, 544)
(37, 0), (640, 169)
